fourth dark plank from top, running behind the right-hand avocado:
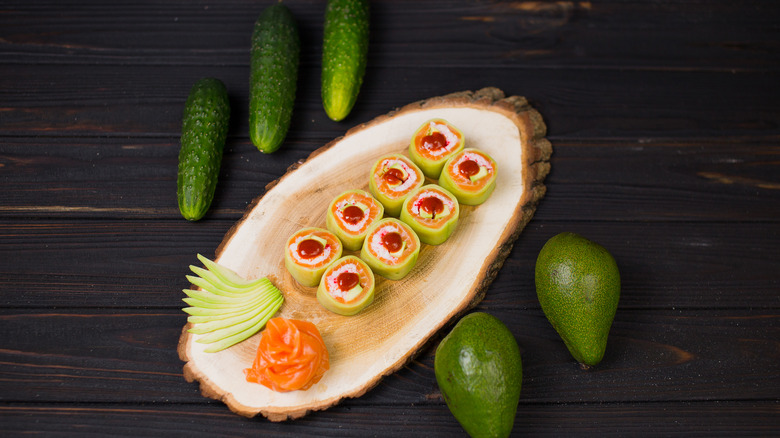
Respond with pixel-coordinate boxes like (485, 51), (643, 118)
(0, 219), (780, 309)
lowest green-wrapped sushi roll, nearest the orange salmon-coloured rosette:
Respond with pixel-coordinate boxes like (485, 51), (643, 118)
(317, 255), (375, 316)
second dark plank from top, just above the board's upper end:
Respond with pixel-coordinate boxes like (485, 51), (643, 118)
(0, 65), (780, 139)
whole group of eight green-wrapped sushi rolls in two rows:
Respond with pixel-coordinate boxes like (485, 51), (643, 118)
(284, 119), (488, 304)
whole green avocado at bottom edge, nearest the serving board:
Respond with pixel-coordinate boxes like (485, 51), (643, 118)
(434, 312), (523, 438)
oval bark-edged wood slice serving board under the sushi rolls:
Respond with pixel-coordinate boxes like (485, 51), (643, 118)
(179, 88), (552, 421)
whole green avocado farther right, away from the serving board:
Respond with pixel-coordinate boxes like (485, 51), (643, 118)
(535, 232), (620, 368)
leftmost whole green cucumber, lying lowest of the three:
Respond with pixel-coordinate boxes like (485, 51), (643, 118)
(176, 78), (230, 221)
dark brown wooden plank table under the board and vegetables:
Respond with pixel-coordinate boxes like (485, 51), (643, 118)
(0, 0), (780, 437)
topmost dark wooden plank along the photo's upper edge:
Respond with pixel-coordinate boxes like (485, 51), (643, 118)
(0, 0), (780, 70)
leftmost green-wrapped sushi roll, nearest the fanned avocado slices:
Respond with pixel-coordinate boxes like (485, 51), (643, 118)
(284, 227), (343, 287)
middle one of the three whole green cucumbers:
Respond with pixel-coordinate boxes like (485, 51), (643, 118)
(249, 3), (301, 153)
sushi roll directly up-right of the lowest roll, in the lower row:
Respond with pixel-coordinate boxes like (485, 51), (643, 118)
(360, 218), (420, 280)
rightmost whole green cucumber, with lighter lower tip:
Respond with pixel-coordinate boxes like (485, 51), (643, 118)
(322, 0), (369, 121)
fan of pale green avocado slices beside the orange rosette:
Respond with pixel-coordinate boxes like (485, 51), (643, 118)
(182, 254), (284, 353)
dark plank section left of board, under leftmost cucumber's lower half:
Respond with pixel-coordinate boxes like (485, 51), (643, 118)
(0, 134), (306, 221)
